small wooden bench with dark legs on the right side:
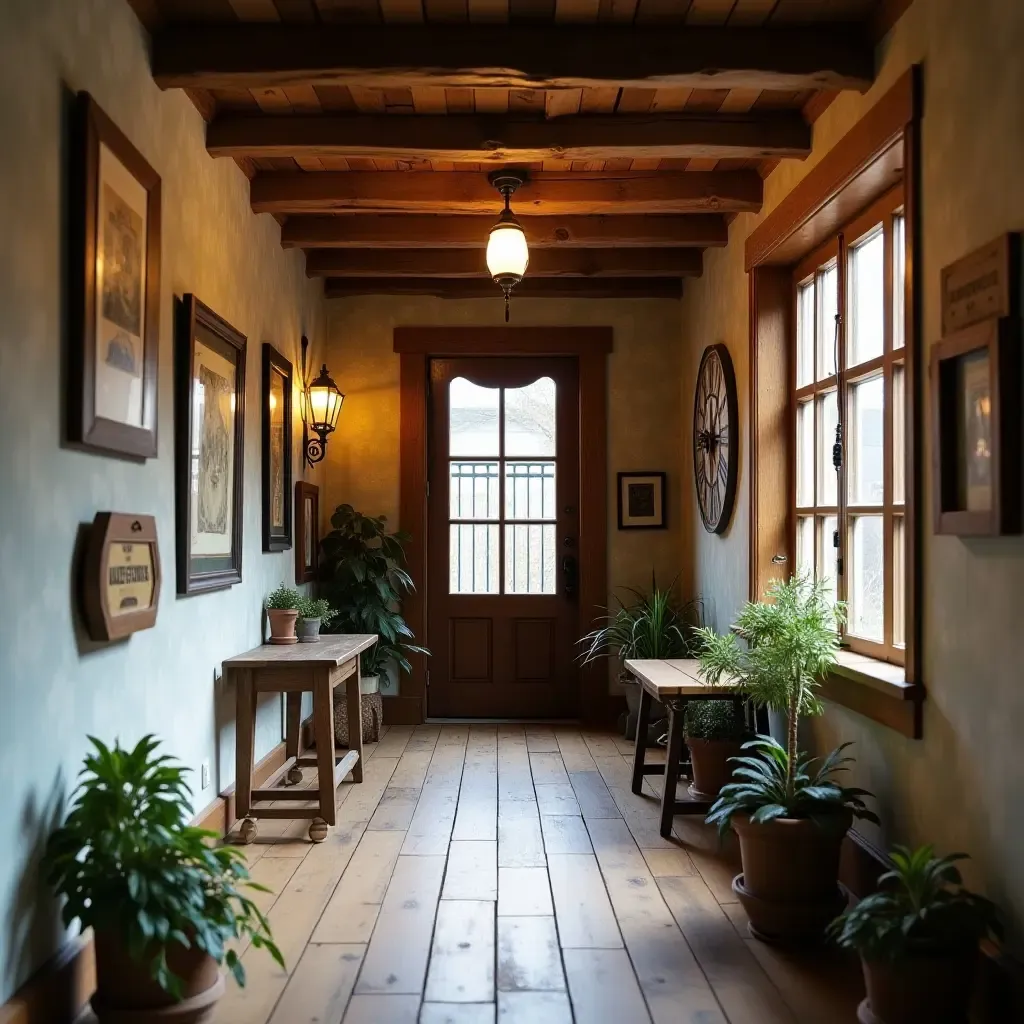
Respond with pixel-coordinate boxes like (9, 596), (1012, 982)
(626, 658), (743, 839)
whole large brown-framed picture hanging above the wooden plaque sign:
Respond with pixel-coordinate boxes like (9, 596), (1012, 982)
(67, 92), (160, 459)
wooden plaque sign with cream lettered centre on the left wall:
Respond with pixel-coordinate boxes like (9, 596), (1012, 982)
(82, 512), (160, 640)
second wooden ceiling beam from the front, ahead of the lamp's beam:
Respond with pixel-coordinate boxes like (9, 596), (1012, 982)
(206, 111), (811, 164)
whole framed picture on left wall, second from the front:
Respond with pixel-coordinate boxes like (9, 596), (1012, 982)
(175, 295), (246, 594)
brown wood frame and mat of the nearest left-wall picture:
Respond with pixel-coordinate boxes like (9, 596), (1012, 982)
(66, 92), (161, 459)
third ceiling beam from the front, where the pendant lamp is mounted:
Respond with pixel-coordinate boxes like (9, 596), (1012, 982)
(250, 171), (764, 217)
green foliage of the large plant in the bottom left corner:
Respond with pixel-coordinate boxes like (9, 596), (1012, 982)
(44, 736), (284, 996)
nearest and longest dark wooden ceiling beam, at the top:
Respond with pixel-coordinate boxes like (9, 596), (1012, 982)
(153, 23), (874, 92)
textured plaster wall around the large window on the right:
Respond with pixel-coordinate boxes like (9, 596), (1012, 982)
(683, 0), (1024, 946)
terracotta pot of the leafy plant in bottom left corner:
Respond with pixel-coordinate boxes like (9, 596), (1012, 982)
(91, 933), (224, 1024)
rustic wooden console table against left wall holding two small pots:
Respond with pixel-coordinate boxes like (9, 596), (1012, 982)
(224, 633), (377, 843)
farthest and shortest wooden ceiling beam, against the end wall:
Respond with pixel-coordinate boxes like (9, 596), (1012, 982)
(324, 278), (683, 302)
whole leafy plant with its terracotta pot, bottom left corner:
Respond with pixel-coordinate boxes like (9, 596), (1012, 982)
(44, 736), (284, 1024)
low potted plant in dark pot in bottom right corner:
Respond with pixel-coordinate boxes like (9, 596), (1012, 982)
(828, 846), (1002, 1024)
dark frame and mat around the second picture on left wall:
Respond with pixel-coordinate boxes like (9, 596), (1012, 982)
(174, 294), (246, 594)
